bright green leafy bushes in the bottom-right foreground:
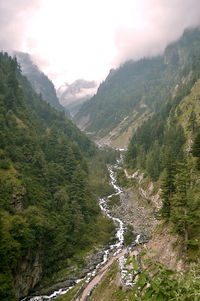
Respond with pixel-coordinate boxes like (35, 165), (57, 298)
(127, 252), (200, 301)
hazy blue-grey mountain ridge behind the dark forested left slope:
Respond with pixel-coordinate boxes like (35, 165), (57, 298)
(14, 52), (70, 117)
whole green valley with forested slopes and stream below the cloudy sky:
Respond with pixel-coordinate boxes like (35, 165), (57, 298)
(0, 28), (200, 301)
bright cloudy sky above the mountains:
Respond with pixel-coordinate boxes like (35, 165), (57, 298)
(0, 0), (200, 87)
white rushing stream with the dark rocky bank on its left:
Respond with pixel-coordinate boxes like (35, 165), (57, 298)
(23, 161), (124, 301)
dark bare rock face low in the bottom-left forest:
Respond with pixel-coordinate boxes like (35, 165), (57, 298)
(14, 252), (42, 298)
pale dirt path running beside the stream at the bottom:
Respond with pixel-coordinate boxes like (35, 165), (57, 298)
(76, 249), (126, 301)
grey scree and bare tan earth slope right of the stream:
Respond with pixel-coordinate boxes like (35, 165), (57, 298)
(119, 170), (184, 271)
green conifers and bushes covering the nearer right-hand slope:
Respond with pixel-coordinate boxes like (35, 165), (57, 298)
(122, 30), (200, 300)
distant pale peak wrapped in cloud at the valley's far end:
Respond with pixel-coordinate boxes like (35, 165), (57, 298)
(57, 79), (97, 116)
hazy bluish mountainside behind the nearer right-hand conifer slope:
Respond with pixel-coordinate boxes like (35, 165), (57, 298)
(74, 28), (200, 147)
